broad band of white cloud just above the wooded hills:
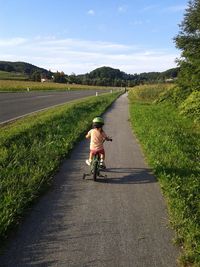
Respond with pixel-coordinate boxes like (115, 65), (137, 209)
(0, 36), (179, 74)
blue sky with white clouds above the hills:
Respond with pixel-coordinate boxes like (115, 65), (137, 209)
(0, 0), (188, 74)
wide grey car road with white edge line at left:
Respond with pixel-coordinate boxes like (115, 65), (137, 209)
(0, 90), (108, 123)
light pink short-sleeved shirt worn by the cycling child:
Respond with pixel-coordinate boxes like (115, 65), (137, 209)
(87, 128), (107, 150)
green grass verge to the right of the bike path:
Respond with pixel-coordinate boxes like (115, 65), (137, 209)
(129, 87), (200, 267)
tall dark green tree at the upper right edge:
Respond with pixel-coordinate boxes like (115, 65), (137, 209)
(175, 0), (200, 93)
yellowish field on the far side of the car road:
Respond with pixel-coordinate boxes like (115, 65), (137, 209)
(0, 80), (119, 92)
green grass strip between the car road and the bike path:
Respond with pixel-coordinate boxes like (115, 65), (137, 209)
(0, 92), (120, 242)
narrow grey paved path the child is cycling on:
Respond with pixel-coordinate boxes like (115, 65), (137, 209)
(0, 95), (179, 267)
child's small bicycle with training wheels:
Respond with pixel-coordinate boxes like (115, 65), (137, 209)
(83, 138), (112, 181)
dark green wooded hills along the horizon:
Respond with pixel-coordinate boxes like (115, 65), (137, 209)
(0, 61), (179, 87)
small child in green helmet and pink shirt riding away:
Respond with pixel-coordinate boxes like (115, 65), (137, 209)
(86, 117), (112, 168)
